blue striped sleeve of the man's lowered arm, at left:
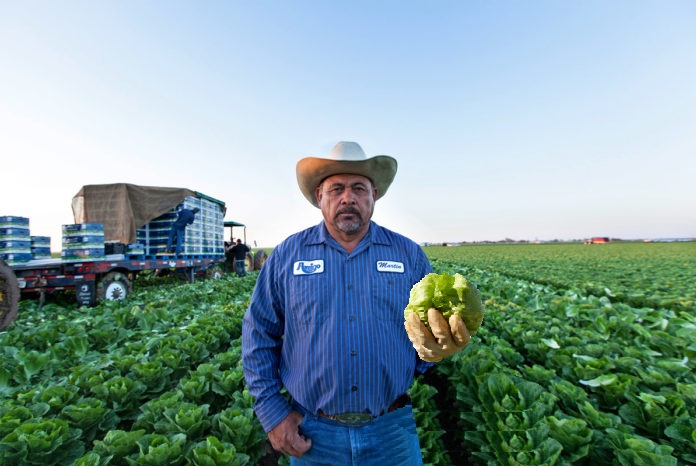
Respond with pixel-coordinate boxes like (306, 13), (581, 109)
(242, 249), (291, 432)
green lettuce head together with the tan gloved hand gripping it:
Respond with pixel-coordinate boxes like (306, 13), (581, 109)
(404, 273), (484, 362)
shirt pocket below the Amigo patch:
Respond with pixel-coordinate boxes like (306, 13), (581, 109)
(288, 273), (331, 325)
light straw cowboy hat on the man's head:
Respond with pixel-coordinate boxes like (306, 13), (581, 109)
(296, 141), (397, 207)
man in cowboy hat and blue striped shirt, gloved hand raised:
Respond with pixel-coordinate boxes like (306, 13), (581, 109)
(242, 142), (469, 466)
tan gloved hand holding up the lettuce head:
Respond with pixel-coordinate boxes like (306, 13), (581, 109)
(404, 308), (471, 362)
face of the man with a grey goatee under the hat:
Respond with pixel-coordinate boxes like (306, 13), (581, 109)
(315, 175), (377, 235)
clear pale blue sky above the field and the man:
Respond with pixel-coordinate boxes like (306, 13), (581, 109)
(0, 0), (696, 250)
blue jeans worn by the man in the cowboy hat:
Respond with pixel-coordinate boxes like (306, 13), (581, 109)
(290, 405), (423, 466)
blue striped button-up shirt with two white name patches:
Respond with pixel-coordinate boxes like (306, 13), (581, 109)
(242, 222), (432, 431)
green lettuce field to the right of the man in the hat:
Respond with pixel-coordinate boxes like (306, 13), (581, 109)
(427, 243), (696, 465)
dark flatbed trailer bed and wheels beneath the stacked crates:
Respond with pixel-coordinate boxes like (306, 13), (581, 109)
(0, 254), (225, 328)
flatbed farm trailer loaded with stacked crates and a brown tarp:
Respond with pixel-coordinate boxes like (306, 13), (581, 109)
(0, 183), (266, 328)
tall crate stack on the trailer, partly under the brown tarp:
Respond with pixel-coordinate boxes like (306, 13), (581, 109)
(135, 196), (225, 257)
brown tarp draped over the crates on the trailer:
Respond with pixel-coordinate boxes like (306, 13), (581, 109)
(72, 183), (201, 244)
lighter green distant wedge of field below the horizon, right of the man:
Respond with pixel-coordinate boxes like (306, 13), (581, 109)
(426, 242), (696, 314)
